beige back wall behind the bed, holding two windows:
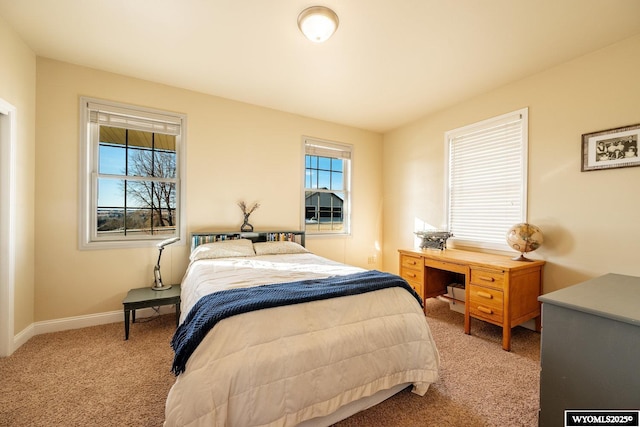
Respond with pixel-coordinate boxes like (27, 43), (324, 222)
(35, 58), (382, 321)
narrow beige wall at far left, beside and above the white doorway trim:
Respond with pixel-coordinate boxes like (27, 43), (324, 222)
(0, 17), (36, 332)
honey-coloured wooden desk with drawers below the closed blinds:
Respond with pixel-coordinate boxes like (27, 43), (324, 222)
(398, 249), (545, 351)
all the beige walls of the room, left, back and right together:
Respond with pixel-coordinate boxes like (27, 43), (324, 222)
(13, 25), (640, 326)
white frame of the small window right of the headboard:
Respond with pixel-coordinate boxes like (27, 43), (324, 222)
(301, 136), (354, 237)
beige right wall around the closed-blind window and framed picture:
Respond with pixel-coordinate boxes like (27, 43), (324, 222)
(383, 36), (640, 293)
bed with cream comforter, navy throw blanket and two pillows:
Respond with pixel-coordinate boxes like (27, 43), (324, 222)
(164, 232), (439, 427)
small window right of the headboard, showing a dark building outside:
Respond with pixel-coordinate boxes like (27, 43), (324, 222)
(304, 138), (352, 234)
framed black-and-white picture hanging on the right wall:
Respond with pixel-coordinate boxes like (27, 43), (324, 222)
(581, 124), (640, 172)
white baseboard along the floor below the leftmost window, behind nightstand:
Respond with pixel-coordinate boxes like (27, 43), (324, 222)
(13, 305), (175, 351)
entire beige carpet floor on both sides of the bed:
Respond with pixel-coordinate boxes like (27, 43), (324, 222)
(0, 300), (540, 427)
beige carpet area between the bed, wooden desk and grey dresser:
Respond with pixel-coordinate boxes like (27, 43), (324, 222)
(338, 300), (540, 427)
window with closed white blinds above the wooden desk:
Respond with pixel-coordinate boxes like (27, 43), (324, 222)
(445, 108), (528, 249)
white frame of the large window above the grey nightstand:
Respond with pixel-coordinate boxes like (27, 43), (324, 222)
(78, 97), (187, 250)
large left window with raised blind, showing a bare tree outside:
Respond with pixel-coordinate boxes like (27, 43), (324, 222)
(80, 98), (186, 249)
